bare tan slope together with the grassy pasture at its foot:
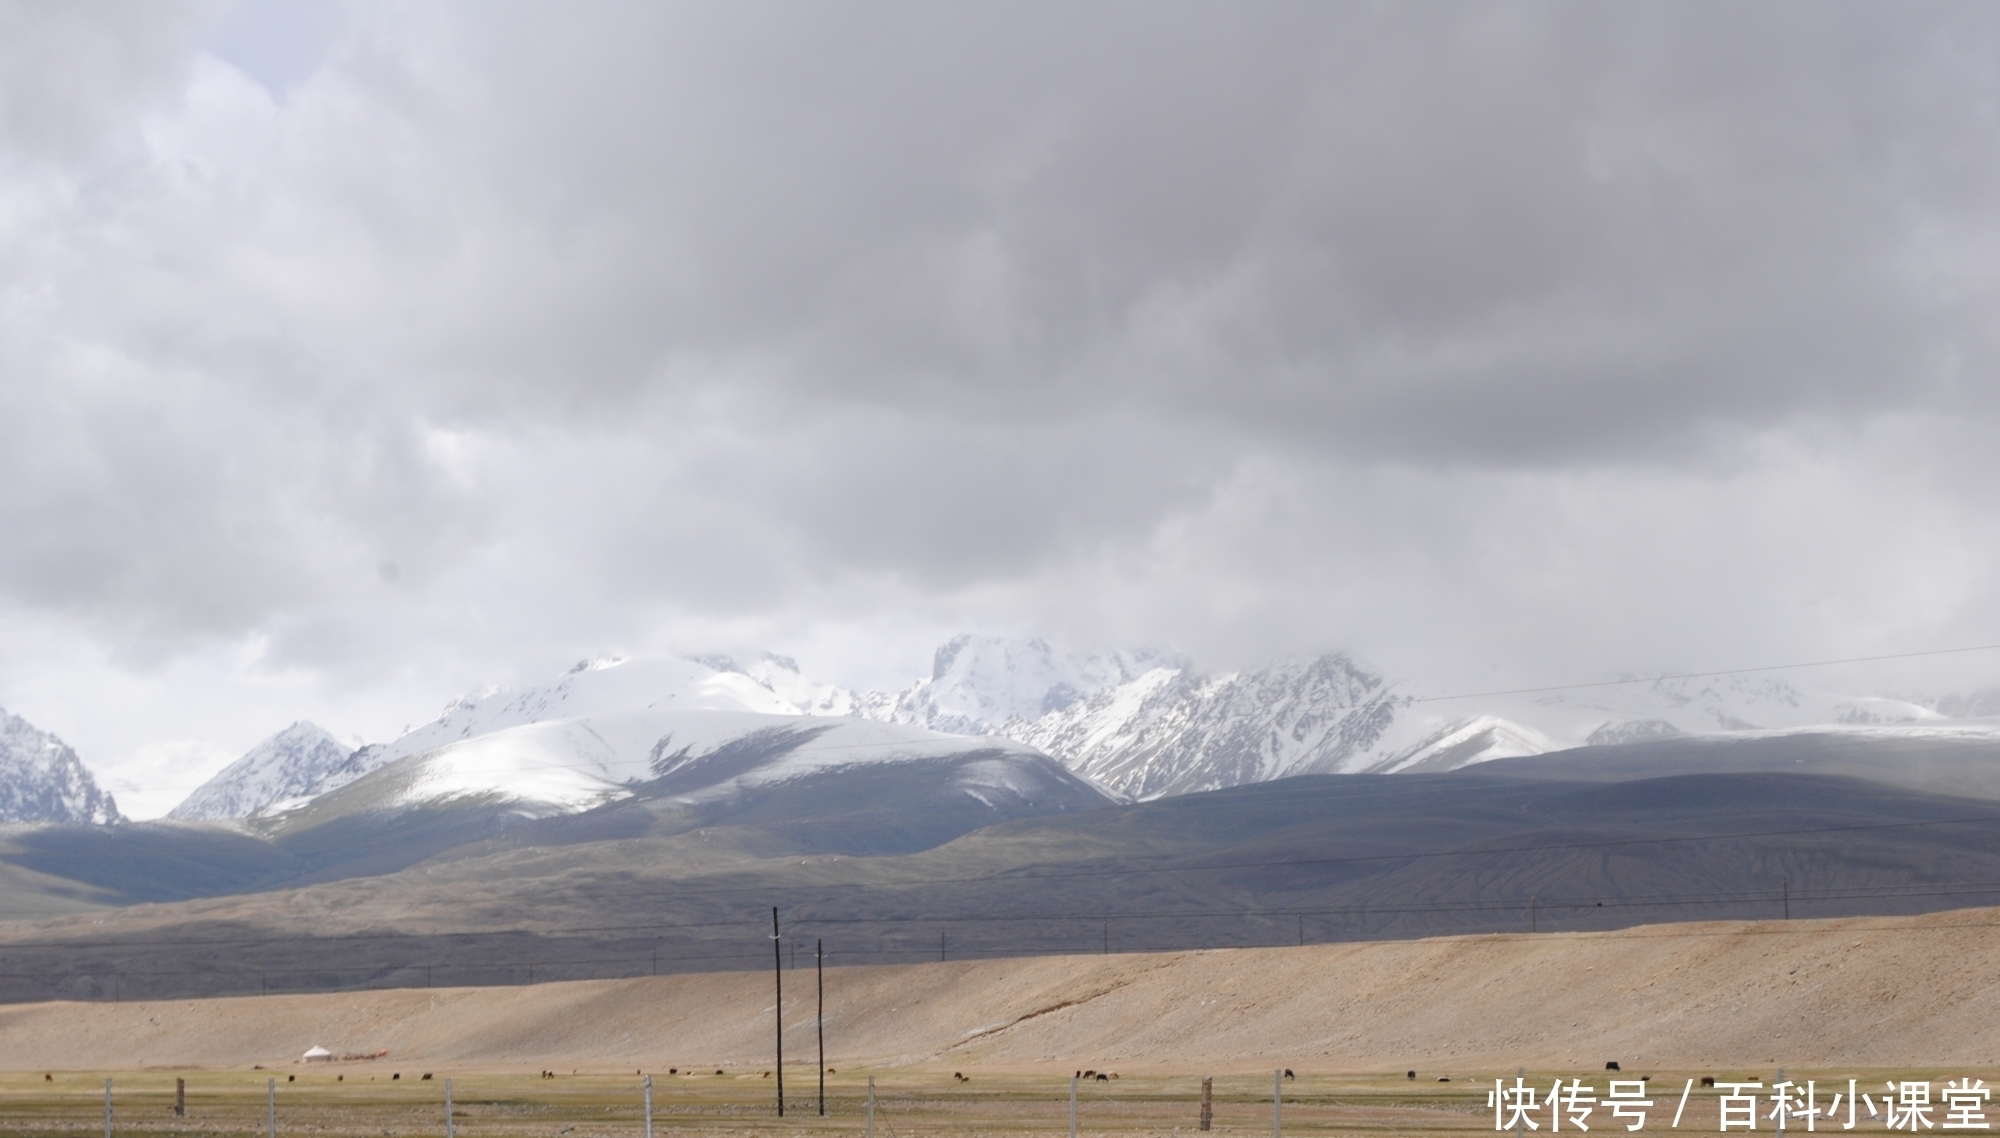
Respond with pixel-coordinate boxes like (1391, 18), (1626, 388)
(0, 910), (2000, 1138)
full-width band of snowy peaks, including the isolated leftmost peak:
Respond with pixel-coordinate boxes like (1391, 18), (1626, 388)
(0, 636), (2000, 822)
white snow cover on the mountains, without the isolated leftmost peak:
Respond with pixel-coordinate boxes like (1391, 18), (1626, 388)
(160, 636), (2000, 818)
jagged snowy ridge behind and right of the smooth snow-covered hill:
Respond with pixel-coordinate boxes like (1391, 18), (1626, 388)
(704, 636), (1946, 798)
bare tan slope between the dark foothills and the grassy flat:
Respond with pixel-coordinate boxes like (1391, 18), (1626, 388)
(0, 910), (2000, 1074)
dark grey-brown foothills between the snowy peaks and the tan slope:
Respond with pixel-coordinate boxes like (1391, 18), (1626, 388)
(11, 728), (2000, 1002)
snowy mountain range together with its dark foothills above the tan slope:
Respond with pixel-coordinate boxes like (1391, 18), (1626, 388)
(0, 638), (2000, 1000)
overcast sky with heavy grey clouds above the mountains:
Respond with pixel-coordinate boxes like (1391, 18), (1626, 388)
(0, 0), (2000, 816)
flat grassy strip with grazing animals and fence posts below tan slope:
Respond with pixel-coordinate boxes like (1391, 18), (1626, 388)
(11, 1062), (1990, 1138)
